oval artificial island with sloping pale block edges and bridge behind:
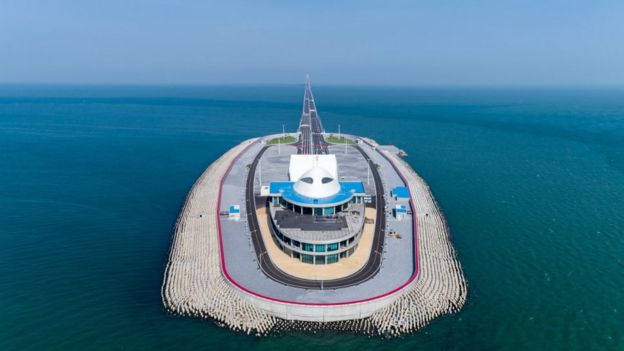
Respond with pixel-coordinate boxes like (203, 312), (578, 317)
(162, 80), (467, 336)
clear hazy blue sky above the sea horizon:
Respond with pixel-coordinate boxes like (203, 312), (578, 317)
(0, 0), (624, 85)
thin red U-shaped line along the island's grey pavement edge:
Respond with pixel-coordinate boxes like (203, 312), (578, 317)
(216, 140), (419, 306)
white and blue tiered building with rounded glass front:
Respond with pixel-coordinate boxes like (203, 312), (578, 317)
(265, 154), (366, 264)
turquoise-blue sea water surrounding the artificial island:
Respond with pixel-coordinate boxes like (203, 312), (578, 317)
(0, 86), (624, 350)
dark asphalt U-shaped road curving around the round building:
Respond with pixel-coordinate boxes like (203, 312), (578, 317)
(245, 145), (386, 290)
